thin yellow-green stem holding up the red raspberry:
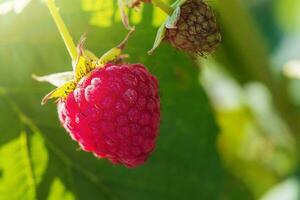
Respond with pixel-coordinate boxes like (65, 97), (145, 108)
(47, 0), (77, 61)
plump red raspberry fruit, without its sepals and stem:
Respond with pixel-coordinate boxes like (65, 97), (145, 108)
(58, 64), (160, 167)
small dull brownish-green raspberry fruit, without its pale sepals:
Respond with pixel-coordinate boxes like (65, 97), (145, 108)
(164, 0), (221, 55)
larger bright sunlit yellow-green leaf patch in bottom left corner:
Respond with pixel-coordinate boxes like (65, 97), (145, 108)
(0, 128), (48, 200)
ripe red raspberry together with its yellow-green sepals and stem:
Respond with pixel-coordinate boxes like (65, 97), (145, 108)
(34, 0), (160, 167)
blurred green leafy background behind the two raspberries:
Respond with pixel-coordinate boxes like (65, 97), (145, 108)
(0, 0), (300, 200)
